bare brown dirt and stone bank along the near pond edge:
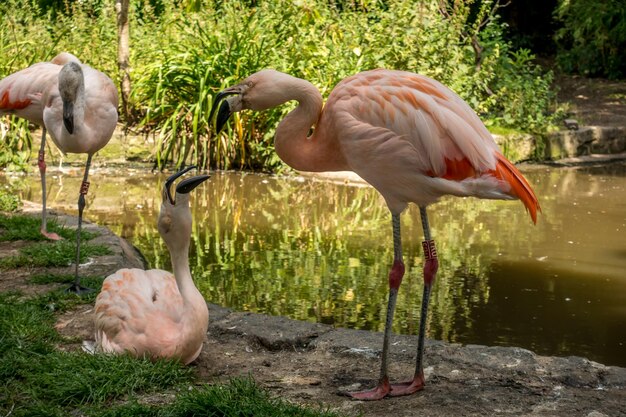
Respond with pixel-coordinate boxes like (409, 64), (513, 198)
(0, 211), (626, 417)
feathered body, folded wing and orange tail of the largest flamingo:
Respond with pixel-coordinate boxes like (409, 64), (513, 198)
(320, 70), (539, 221)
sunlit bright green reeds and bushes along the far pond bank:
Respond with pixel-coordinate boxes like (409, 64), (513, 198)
(0, 0), (551, 171)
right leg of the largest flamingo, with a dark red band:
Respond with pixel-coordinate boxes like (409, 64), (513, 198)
(389, 207), (439, 397)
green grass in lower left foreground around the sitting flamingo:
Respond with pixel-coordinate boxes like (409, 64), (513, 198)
(0, 282), (346, 417)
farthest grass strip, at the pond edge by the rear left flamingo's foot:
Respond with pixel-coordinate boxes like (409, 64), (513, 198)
(0, 215), (98, 242)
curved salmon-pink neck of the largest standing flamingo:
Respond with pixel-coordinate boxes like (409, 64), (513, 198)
(274, 78), (348, 172)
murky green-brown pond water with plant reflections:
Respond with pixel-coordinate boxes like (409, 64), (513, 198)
(0, 163), (626, 366)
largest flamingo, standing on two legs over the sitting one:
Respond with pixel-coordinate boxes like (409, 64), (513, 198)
(211, 69), (541, 400)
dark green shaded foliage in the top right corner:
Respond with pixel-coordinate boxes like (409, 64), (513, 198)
(555, 0), (626, 78)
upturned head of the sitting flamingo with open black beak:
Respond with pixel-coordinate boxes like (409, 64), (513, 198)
(157, 166), (209, 247)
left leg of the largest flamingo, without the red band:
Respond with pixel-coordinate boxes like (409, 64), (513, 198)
(348, 214), (404, 400)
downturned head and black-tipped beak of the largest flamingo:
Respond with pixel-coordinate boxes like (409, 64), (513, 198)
(209, 69), (297, 133)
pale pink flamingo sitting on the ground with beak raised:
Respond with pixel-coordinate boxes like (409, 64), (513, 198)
(95, 167), (209, 364)
